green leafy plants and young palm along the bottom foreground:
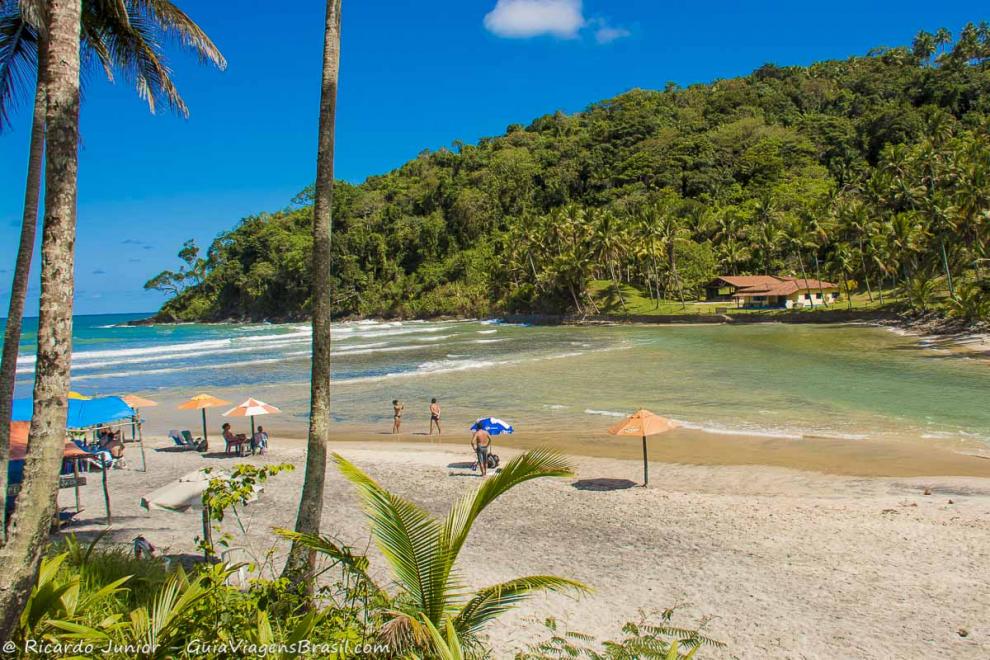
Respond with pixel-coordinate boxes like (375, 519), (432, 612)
(12, 450), (720, 660)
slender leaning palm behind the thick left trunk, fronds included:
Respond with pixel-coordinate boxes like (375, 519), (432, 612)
(0, 0), (226, 538)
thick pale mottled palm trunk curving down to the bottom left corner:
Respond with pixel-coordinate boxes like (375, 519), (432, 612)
(0, 0), (82, 639)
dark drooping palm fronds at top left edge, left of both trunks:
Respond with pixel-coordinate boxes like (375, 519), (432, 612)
(0, 5), (38, 132)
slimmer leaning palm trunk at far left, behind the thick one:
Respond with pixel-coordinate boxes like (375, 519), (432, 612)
(0, 37), (45, 543)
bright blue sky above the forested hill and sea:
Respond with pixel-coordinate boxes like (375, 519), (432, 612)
(0, 0), (987, 315)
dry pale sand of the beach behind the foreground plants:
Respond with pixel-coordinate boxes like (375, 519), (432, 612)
(60, 440), (990, 658)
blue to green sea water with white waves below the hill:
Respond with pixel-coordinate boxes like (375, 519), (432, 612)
(1, 315), (990, 443)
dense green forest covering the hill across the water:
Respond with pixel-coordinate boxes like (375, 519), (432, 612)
(146, 23), (990, 320)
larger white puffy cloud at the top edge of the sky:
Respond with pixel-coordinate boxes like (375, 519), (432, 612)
(485, 0), (586, 39)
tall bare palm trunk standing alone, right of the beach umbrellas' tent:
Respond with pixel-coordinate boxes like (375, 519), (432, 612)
(282, 0), (341, 595)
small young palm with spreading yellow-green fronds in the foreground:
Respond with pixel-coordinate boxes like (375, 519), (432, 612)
(279, 449), (587, 654)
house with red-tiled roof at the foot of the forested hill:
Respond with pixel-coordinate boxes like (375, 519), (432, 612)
(705, 275), (839, 309)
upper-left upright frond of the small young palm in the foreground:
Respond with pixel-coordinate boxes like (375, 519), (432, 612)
(333, 454), (454, 622)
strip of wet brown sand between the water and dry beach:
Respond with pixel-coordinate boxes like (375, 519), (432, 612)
(142, 390), (990, 478)
